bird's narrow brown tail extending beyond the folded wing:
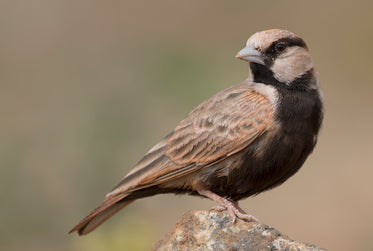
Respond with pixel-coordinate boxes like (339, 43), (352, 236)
(69, 194), (134, 235)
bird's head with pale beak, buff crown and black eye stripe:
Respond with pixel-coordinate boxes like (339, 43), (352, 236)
(236, 29), (317, 89)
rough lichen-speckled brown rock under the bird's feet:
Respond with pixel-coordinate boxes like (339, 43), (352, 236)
(153, 211), (325, 251)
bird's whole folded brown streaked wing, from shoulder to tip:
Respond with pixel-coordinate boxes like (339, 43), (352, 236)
(107, 82), (274, 199)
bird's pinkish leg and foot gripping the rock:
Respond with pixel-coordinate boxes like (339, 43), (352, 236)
(197, 189), (258, 222)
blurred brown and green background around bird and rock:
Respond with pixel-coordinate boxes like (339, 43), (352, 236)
(0, 0), (373, 251)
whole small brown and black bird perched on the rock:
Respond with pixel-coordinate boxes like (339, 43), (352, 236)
(69, 29), (324, 235)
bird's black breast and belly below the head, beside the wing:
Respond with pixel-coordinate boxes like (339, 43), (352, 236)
(211, 72), (323, 200)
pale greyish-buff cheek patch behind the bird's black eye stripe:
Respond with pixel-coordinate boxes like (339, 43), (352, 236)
(271, 47), (313, 84)
